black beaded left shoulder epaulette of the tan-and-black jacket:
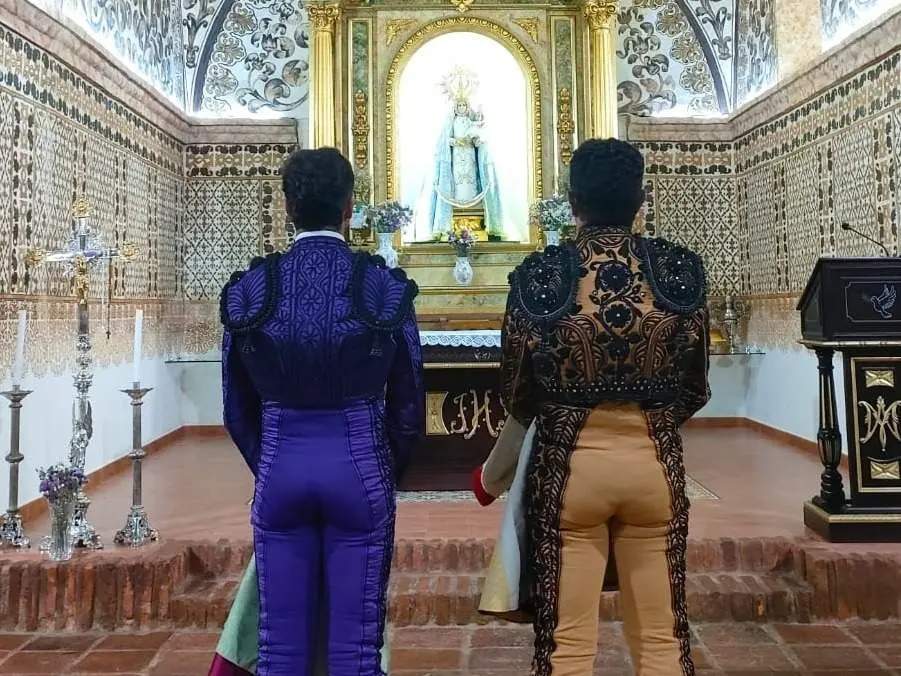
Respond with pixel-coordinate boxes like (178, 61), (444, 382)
(509, 243), (579, 324)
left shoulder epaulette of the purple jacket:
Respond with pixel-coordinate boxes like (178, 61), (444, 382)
(219, 253), (281, 333)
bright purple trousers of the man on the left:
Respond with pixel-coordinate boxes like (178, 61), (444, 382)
(252, 402), (395, 676)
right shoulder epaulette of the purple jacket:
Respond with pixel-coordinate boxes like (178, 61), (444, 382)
(350, 252), (419, 332)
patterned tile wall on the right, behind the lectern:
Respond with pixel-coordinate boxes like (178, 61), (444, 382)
(639, 43), (901, 346)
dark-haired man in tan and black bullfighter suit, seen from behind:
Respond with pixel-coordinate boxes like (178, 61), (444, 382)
(474, 140), (710, 676)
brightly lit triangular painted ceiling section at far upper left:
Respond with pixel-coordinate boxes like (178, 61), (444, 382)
(24, 0), (185, 107)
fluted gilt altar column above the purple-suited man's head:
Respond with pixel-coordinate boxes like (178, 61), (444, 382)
(307, 2), (341, 148)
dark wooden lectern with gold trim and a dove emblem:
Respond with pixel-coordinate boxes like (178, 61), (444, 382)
(798, 258), (901, 542)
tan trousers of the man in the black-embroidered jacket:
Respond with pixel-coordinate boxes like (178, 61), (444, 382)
(551, 405), (694, 676)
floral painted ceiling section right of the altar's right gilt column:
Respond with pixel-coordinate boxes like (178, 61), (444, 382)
(617, 0), (776, 117)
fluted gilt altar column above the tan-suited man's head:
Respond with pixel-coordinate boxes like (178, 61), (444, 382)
(585, 0), (619, 138)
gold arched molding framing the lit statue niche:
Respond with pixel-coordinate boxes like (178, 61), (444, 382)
(385, 16), (544, 239)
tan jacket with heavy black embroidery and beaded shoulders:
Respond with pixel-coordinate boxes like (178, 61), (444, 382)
(501, 230), (710, 426)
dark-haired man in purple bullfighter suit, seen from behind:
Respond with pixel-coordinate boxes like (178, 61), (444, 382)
(221, 149), (424, 676)
